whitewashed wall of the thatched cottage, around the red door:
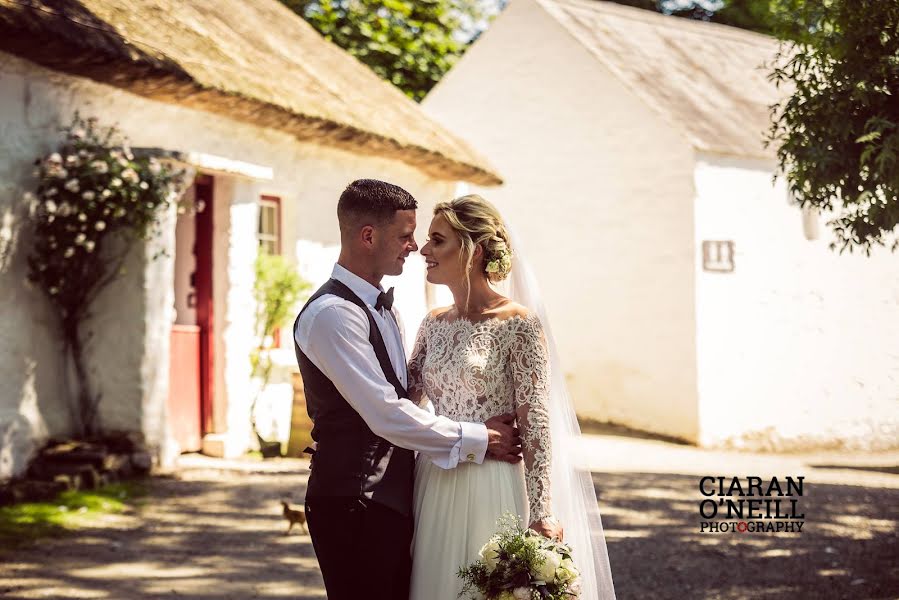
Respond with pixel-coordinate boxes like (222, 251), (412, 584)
(0, 53), (453, 478)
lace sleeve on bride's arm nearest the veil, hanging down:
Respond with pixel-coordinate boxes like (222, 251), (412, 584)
(509, 315), (552, 523)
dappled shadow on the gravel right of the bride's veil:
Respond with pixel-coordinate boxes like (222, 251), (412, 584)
(593, 473), (899, 600)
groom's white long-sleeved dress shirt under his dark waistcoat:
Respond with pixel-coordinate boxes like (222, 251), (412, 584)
(294, 265), (487, 469)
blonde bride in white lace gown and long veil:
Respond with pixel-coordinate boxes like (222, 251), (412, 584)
(408, 195), (615, 600)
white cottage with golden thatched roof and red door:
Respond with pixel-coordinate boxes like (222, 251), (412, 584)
(0, 0), (499, 478)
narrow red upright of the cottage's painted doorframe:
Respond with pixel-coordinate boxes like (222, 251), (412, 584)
(194, 175), (215, 435)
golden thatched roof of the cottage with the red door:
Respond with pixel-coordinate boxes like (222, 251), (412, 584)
(0, 0), (501, 185)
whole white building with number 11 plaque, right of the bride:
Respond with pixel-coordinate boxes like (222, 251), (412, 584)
(423, 0), (899, 448)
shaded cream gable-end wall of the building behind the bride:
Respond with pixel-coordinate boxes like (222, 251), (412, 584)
(424, 0), (699, 439)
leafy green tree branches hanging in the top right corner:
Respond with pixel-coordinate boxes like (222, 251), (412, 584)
(769, 0), (899, 254)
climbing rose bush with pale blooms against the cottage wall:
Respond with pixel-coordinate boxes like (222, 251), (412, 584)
(26, 114), (183, 436)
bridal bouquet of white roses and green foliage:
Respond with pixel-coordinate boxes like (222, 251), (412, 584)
(459, 515), (581, 600)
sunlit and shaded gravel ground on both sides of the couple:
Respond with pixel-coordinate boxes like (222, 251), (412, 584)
(0, 435), (899, 600)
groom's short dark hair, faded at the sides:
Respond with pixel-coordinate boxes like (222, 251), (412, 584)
(337, 179), (418, 233)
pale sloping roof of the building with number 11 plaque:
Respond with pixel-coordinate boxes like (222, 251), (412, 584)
(537, 0), (779, 158)
